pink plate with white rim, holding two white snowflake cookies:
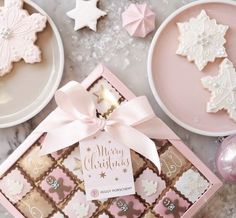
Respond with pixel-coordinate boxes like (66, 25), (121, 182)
(148, 0), (236, 136)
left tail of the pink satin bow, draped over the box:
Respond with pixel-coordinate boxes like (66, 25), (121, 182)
(40, 120), (99, 155)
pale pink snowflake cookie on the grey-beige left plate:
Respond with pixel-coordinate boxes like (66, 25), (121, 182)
(0, 0), (47, 76)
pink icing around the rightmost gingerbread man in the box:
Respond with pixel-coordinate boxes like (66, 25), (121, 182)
(153, 189), (190, 218)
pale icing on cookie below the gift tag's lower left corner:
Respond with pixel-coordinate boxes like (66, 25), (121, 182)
(63, 190), (97, 217)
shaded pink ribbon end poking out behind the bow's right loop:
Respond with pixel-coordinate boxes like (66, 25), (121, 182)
(134, 117), (180, 140)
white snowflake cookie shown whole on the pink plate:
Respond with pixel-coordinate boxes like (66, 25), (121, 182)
(176, 10), (229, 71)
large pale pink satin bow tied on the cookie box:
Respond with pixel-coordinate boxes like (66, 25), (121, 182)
(41, 81), (178, 170)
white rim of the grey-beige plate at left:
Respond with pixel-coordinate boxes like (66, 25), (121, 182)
(0, 0), (65, 129)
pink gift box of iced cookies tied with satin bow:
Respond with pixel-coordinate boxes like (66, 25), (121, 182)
(0, 65), (222, 218)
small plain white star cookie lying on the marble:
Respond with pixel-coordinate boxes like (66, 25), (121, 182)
(67, 0), (107, 32)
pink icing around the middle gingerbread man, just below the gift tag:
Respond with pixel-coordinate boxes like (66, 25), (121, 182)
(108, 195), (145, 218)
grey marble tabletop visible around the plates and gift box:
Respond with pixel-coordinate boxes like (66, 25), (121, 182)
(0, 0), (236, 218)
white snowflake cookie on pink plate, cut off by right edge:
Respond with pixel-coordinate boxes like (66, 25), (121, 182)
(201, 58), (236, 121)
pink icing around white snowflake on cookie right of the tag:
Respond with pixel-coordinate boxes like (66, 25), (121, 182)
(135, 168), (166, 204)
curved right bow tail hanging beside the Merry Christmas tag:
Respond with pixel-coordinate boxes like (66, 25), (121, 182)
(107, 124), (161, 172)
